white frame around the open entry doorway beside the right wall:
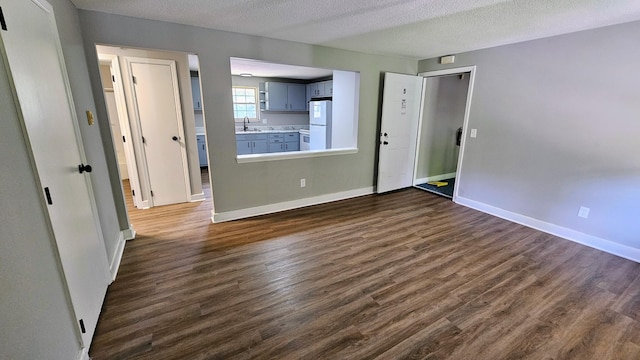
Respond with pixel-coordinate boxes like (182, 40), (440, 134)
(413, 65), (476, 203)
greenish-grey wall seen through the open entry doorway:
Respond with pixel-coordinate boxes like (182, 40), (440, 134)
(415, 73), (469, 179)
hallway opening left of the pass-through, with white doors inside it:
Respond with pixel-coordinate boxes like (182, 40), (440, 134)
(96, 45), (208, 214)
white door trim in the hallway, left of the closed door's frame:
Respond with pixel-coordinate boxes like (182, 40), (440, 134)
(98, 53), (142, 211)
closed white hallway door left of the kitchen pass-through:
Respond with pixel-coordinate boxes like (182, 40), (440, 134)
(127, 58), (190, 206)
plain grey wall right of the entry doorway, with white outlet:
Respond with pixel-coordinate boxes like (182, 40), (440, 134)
(419, 21), (640, 249)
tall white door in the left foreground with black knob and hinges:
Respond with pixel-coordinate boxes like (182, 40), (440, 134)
(0, 0), (109, 346)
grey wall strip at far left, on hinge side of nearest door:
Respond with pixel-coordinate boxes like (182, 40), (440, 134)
(0, 1), (83, 360)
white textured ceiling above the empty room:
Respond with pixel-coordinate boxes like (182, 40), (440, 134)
(71, 0), (640, 59)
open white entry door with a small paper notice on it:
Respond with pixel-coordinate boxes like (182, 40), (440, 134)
(376, 73), (423, 193)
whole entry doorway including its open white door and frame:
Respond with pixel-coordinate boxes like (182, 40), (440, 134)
(376, 66), (476, 201)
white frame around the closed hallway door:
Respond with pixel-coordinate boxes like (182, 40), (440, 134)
(123, 56), (192, 207)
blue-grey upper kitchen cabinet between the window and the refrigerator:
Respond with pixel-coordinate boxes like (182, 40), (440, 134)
(264, 81), (307, 111)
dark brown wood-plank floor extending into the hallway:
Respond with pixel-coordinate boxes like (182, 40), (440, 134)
(90, 172), (640, 360)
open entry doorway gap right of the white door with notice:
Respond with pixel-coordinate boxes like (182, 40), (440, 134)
(413, 72), (471, 199)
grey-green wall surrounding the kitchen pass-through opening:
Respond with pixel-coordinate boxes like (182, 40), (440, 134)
(79, 10), (417, 213)
